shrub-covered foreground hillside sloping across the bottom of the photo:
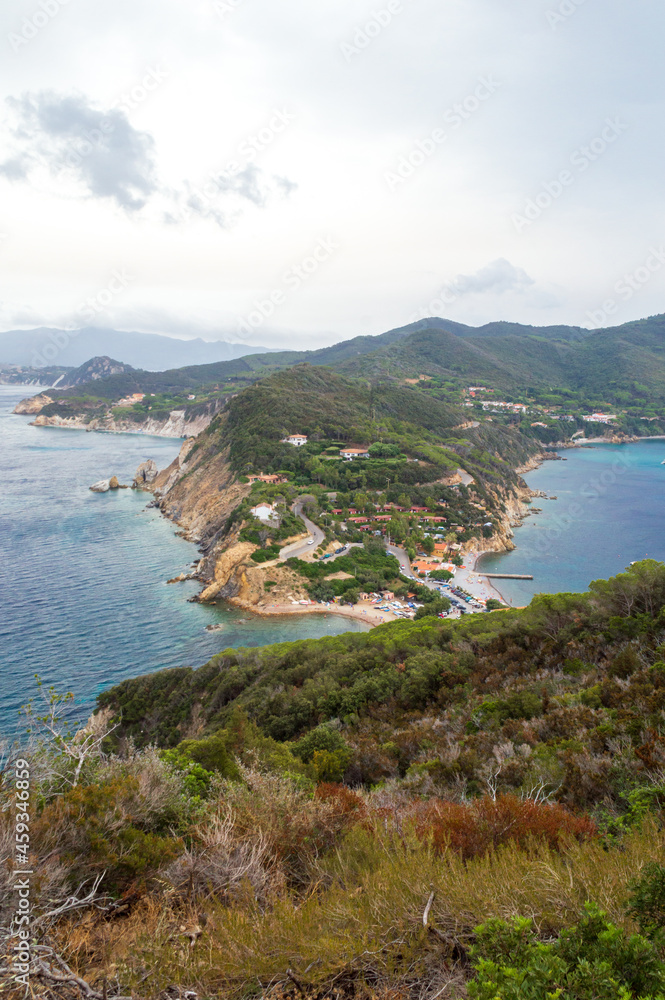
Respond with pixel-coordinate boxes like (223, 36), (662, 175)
(10, 561), (665, 1000)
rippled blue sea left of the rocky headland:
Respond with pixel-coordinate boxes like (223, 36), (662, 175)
(0, 386), (366, 735)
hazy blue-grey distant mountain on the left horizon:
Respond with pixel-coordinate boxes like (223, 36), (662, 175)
(0, 327), (271, 371)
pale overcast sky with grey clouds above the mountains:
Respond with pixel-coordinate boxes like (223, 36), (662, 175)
(0, 0), (665, 348)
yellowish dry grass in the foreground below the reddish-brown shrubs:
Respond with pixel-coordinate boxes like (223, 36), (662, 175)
(44, 824), (665, 1000)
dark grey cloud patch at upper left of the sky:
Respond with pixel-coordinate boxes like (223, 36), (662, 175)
(0, 91), (158, 212)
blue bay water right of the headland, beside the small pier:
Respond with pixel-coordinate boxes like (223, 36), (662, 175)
(479, 440), (665, 606)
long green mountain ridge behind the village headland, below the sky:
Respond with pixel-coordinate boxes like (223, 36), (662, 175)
(35, 308), (665, 414)
